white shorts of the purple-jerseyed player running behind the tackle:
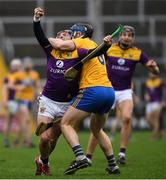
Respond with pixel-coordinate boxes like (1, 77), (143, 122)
(112, 89), (133, 109)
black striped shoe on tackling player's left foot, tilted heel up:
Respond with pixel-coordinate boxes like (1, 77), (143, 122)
(64, 158), (89, 175)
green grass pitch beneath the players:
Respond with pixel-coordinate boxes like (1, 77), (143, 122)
(0, 132), (166, 179)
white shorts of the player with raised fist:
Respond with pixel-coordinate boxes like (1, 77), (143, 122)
(38, 95), (70, 120)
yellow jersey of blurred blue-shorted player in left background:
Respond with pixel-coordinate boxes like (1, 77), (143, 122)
(14, 70), (39, 102)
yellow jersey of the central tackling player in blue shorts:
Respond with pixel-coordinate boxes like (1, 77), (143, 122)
(73, 38), (112, 89)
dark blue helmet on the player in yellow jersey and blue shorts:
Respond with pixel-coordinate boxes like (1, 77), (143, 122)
(70, 23), (93, 38)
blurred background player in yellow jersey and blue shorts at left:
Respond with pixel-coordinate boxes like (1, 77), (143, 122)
(12, 57), (41, 148)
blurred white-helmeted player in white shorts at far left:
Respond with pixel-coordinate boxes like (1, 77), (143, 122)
(2, 59), (21, 147)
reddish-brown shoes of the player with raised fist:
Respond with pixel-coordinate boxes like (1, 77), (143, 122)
(35, 157), (51, 176)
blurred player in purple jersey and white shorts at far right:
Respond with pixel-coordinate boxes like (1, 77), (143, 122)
(145, 73), (163, 140)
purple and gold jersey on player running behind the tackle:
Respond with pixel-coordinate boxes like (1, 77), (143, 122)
(106, 44), (149, 91)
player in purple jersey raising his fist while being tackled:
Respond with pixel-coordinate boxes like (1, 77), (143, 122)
(33, 8), (89, 175)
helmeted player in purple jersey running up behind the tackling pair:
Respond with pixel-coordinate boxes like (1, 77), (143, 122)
(87, 26), (159, 164)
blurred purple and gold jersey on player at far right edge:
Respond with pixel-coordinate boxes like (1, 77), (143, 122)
(145, 77), (163, 102)
